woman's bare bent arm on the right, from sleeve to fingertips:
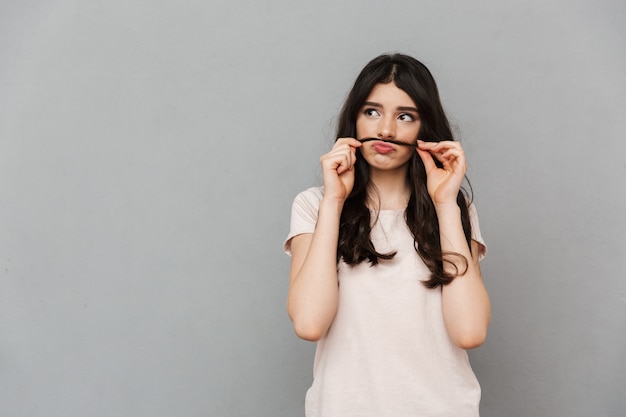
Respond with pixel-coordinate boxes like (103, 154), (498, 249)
(417, 141), (491, 349)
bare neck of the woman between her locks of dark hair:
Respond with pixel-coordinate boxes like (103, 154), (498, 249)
(367, 167), (411, 210)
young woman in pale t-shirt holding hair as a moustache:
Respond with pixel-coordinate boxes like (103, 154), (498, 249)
(285, 54), (490, 417)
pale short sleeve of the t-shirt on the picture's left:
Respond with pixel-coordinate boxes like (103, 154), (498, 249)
(283, 187), (324, 256)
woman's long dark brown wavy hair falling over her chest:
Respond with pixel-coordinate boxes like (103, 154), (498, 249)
(337, 54), (471, 288)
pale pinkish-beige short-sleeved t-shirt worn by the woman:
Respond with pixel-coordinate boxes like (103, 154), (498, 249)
(285, 187), (486, 417)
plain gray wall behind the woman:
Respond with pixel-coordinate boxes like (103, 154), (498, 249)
(0, 0), (626, 417)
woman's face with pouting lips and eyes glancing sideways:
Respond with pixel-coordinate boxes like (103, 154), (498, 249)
(356, 82), (421, 171)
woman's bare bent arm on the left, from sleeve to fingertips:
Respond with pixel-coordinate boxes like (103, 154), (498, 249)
(287, 138), (361, 341)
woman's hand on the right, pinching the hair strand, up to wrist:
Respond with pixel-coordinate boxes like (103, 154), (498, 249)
(417, 140), (467, 206)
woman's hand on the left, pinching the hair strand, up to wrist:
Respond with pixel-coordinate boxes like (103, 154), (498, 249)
(320, 138), (362, 203)
